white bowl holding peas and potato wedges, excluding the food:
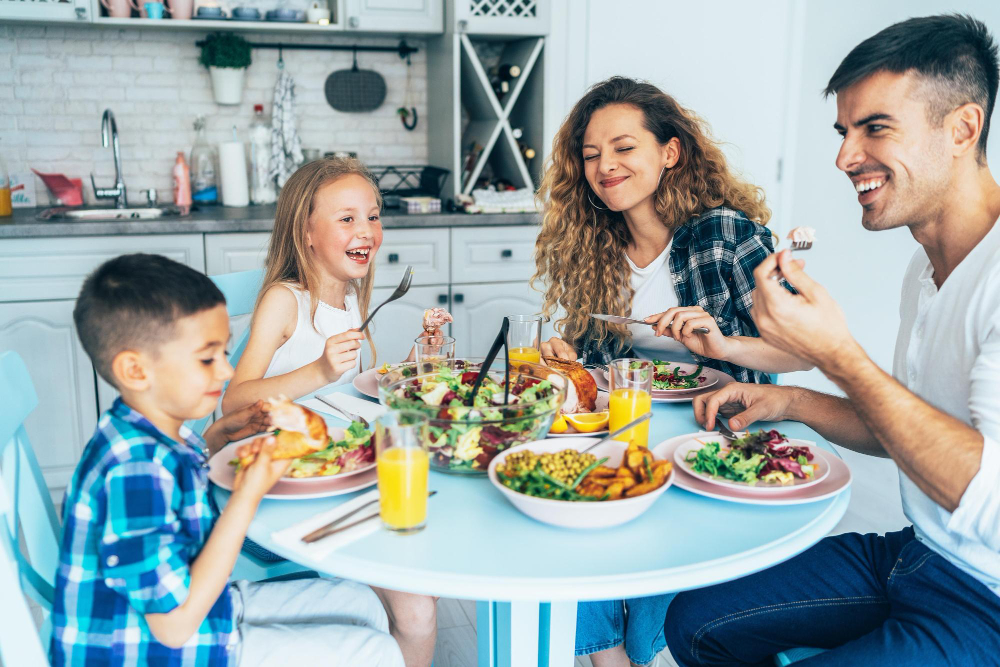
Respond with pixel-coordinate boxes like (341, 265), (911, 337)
(487, 437), (674, 528)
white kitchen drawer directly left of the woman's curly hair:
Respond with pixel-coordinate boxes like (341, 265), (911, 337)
(451, 225), (538, 283)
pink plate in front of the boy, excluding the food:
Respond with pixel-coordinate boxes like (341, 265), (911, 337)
(208, 428), (375, 500)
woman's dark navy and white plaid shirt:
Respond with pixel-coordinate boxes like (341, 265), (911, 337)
(581, 206), (774, 383)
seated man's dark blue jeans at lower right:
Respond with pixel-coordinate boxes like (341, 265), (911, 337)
(665, 528), (1000, 667)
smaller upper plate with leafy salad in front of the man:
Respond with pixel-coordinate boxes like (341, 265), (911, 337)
(673, 429), (830, 493)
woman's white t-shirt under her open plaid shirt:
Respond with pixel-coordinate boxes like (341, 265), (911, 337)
(625, 239), (694, 361)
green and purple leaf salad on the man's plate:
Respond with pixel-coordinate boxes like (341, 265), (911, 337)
(685, 429), (817, 486)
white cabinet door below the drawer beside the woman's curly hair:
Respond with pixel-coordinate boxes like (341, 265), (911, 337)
(451, 283), (547, 357)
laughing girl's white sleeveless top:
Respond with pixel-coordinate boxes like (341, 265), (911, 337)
(264, 283), (361, 387)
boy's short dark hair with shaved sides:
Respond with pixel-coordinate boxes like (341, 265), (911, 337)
(73, 253), (226, 385)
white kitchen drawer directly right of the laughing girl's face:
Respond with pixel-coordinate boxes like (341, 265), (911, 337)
(375, 228), (448, 288)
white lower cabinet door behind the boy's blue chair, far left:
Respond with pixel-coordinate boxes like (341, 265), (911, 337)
(0, 300), (97, 489)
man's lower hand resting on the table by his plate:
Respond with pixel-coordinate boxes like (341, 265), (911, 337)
(692, 382), (796, 431)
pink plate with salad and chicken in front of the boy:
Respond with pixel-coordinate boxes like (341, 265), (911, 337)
(209, 399), (375, 498)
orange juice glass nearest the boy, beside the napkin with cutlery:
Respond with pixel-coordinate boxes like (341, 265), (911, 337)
(375, 410), (430, 534)
